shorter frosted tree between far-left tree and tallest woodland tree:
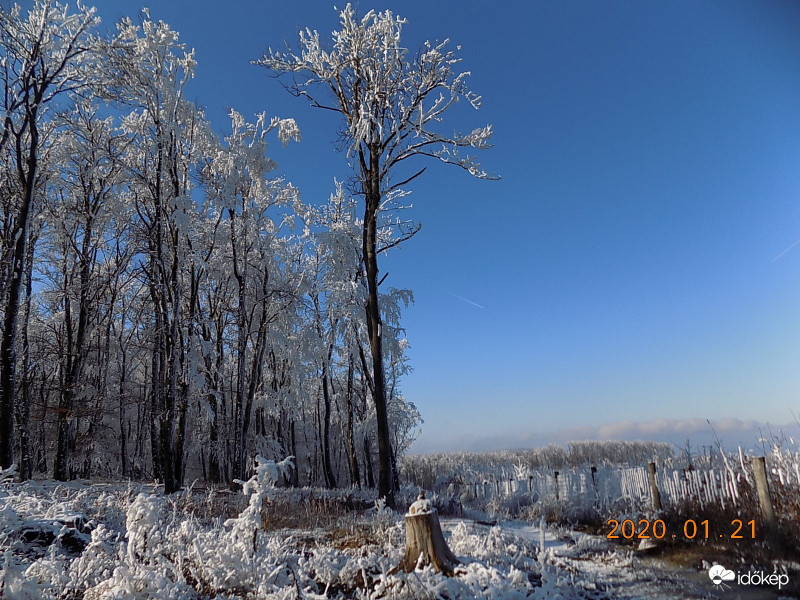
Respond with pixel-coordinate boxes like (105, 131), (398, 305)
(39, 101), (129, 481)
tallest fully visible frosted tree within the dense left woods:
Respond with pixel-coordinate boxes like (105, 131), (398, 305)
(101, 10), (211, 493)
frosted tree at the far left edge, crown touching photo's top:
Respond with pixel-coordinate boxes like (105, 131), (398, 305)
(0, 0), (97, 468)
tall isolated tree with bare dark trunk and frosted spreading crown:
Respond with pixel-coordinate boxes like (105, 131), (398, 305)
(255, 4), (492, 505)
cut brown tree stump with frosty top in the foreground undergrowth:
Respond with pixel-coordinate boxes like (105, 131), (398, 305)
(391, 492), (459, 577)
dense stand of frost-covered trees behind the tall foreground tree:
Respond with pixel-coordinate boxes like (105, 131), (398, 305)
(0, 1), (421, 492)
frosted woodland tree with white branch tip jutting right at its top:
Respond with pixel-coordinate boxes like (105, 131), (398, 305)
(203, 110), (299, 478)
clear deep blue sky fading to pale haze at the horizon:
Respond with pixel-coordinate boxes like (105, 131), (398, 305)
(28, 0), (800, 451)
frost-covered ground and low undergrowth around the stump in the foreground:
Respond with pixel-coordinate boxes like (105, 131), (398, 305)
(0, 476), (796, 600)
